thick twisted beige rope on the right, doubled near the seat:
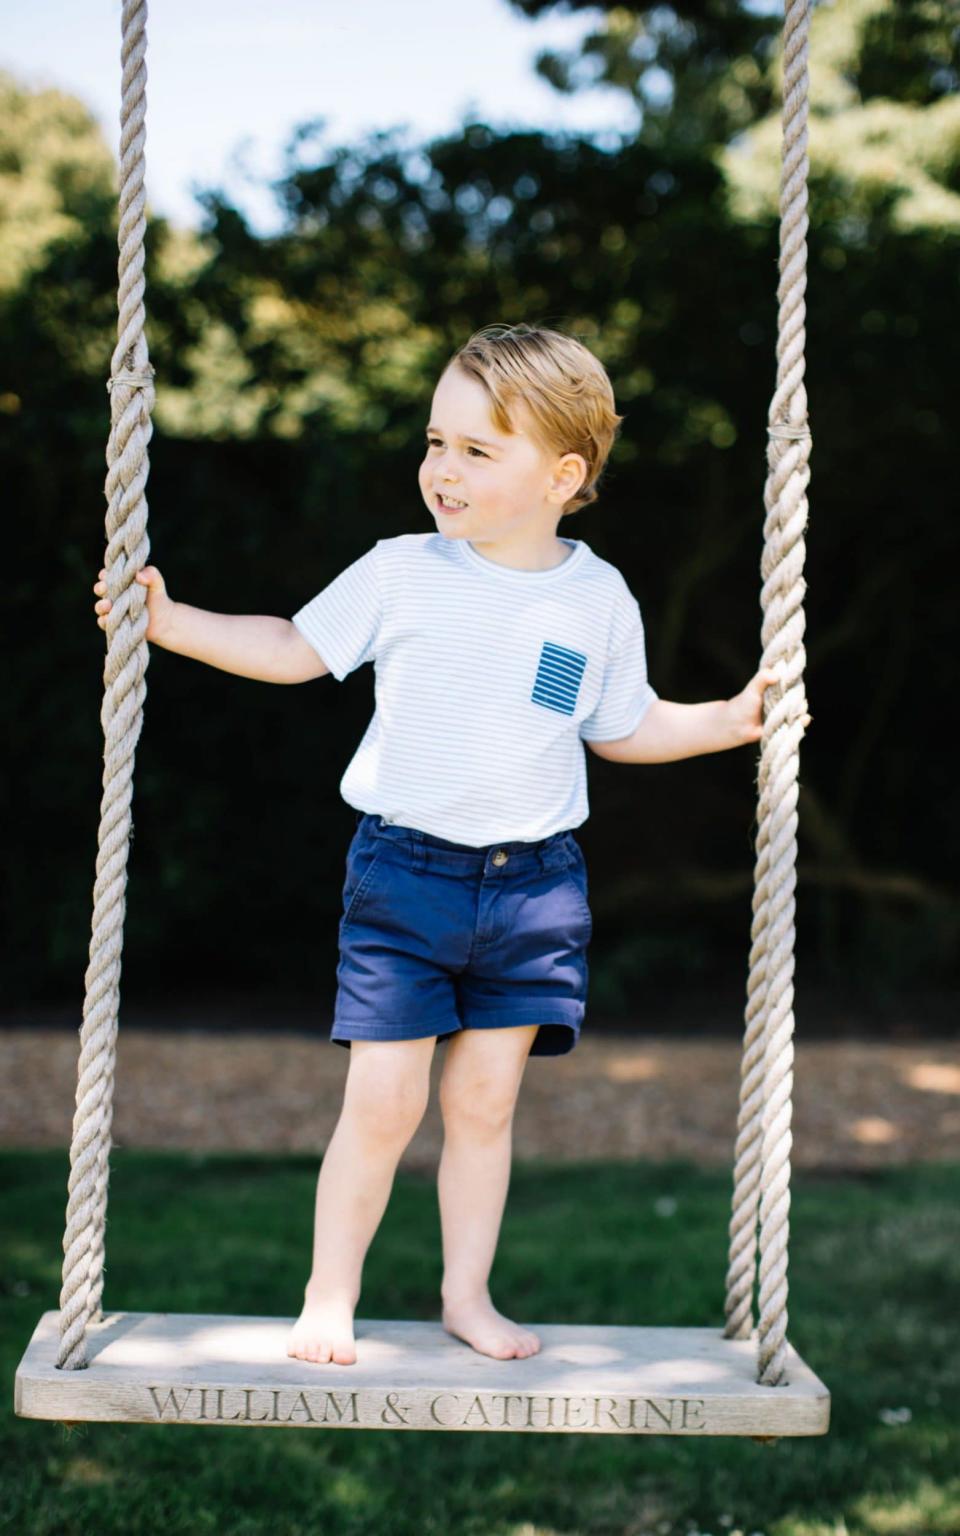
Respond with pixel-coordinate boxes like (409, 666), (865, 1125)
(723, 0), (811, 1387)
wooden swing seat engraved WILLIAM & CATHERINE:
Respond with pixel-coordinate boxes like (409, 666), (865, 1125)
(15, 1312), (829, 1439)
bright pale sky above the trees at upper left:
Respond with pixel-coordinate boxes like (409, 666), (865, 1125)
(0, 0), (639, 233)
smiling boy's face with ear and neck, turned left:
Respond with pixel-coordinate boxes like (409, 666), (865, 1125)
(419, 364), (587, 553)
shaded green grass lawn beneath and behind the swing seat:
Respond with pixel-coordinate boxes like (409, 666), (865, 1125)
(0, 1149), (960, 1536)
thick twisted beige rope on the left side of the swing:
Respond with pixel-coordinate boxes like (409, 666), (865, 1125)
(57, 0), (154, 1370)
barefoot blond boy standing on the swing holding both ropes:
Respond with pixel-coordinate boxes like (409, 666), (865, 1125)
(94, 326), (777, 1366)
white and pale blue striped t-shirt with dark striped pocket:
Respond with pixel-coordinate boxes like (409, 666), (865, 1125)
(293, 533), (657, 848)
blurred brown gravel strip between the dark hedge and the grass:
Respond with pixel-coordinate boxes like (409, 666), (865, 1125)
(0, 1025), (960, 1170)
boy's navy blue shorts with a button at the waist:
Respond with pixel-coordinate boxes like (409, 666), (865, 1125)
(330, 811), (593, 1055)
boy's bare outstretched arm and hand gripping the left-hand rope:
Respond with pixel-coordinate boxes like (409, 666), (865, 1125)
(94, 565), (330, 682)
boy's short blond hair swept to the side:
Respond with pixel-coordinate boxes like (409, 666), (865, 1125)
(447, 324), (624, 518)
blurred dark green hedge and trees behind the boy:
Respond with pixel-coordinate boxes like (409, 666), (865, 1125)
(0, 0), (960, 1023)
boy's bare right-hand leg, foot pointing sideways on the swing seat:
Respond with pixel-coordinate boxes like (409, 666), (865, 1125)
(436, 1025), (541, 1359)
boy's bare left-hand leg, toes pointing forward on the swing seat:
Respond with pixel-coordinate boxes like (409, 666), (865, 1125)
(287, 1035), (436, 1366)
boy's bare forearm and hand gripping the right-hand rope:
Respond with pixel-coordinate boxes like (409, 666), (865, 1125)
(585, 667), (813, 763)
